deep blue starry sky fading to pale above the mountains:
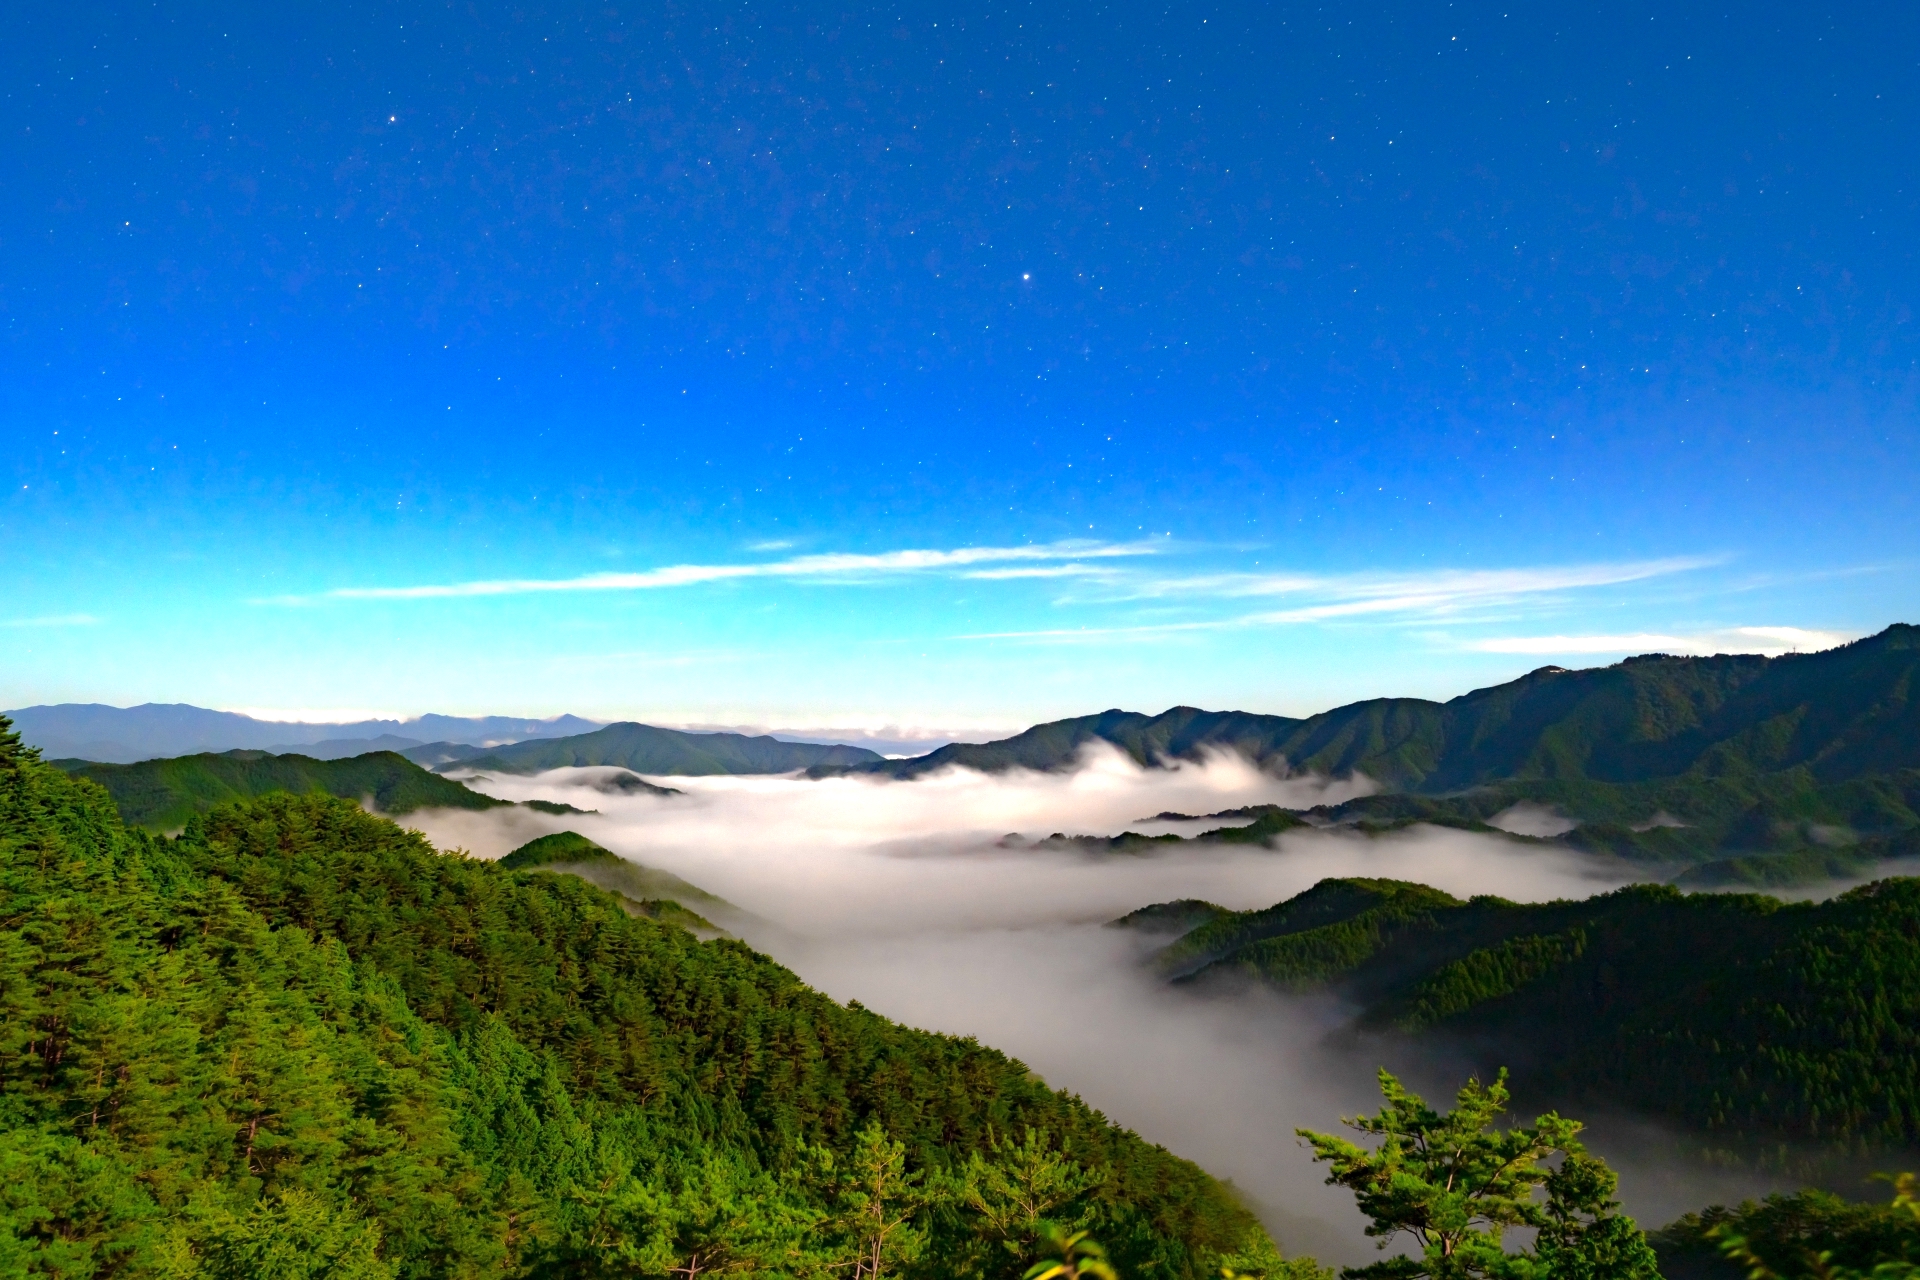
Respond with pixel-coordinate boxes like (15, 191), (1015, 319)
(0, 2), (1920, 727)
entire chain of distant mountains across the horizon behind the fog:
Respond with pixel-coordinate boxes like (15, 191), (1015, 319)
(13, 624), (1920, 885)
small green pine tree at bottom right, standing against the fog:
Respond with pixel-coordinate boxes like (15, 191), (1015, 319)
(1298, 1071), (1659, 1280)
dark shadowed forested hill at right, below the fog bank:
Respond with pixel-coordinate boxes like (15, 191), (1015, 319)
(1119, 879), (1920, 1150)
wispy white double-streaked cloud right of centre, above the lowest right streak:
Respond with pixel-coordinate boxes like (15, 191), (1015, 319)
(956, 557), (1720, 641)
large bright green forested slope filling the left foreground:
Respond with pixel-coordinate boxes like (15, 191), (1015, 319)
(0, 720), (1281, 1280)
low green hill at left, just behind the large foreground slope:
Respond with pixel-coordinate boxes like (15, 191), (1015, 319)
(60, 750), (507, 831)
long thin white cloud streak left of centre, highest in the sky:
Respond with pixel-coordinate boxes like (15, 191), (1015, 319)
(259, 539), (1164, 604)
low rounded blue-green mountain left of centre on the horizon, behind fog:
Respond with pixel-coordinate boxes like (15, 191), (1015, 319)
(436, 722), (881, 777)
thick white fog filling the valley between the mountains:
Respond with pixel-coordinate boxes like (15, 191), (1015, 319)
(409, 750), (1797, 1265)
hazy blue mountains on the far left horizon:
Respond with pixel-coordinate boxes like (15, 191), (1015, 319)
(6, 702), (601, 764)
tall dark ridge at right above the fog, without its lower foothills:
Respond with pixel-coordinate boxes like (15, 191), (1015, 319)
(860, 624), (1920, 794)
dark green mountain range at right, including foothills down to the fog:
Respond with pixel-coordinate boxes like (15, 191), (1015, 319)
(829, 624), (1920, 885)
